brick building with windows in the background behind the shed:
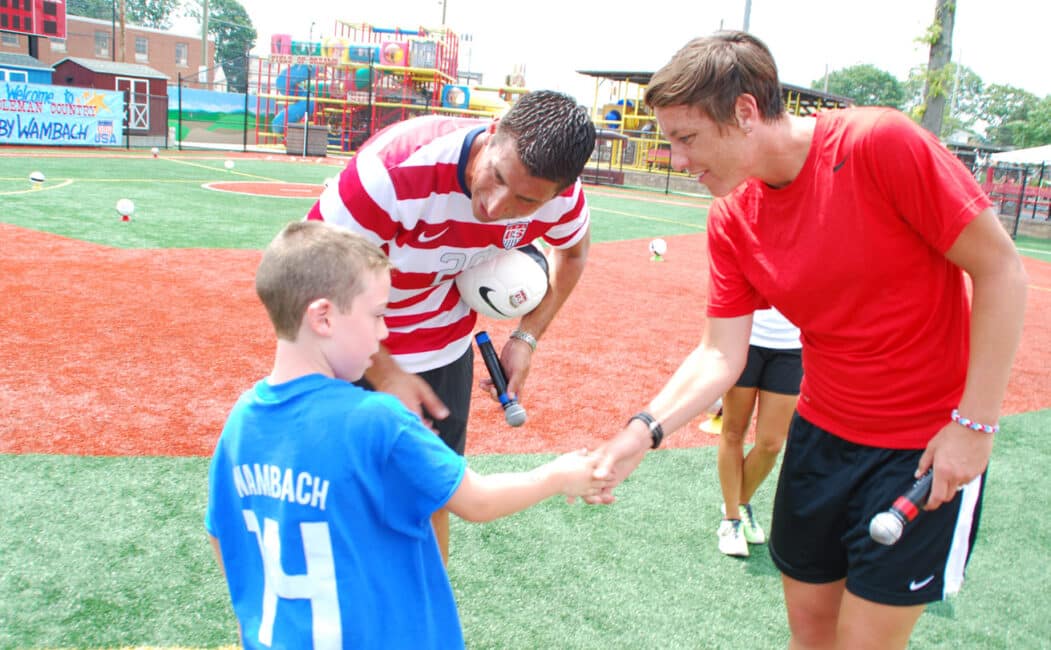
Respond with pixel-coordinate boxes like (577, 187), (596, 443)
(0, 16), (215, 90)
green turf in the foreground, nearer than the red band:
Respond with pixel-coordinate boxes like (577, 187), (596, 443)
(0, 409), (1051, 650)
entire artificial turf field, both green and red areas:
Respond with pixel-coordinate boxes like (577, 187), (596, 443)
(0, 149), (1051, 648)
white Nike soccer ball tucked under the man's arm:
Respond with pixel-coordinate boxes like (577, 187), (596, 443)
(456, 244), (548, 321)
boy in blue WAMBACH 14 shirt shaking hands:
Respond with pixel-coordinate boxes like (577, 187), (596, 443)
(205, 221), (601, 648)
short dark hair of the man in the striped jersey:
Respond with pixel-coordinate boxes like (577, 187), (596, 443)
(496, 90), (595, 188)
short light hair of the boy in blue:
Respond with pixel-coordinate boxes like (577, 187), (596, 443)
(255, 221), (391, 341)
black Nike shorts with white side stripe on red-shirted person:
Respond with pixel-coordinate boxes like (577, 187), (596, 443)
(769, 413), (985, 606)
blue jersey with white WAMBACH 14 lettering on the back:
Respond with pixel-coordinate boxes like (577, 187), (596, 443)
(205, 374), (466, 649)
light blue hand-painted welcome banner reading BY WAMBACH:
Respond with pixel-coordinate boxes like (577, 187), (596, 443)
(0, 82), (124, 146)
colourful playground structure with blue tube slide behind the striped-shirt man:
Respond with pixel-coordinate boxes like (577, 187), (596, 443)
(255, 20), (528, 154)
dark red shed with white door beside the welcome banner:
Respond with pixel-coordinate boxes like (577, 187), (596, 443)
(53, 57), (168, 146)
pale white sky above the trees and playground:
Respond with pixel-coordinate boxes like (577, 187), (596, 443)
(225, 0), (1051, 105)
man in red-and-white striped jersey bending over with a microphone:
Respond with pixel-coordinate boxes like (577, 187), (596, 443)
(307, 90), (595, 560)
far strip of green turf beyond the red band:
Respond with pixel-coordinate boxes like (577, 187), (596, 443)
(0, 151), (706, 248)
